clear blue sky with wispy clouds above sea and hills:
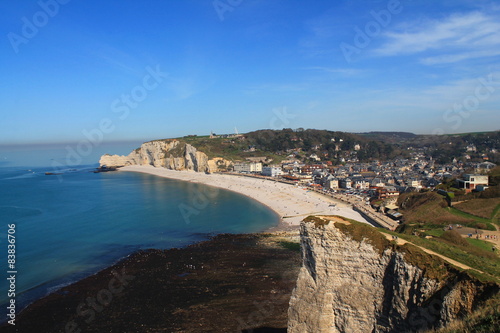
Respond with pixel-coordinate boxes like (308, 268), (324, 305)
(0, 0), (500, 144)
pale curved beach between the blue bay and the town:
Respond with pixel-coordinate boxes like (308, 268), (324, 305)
(120, 166), (368, 229)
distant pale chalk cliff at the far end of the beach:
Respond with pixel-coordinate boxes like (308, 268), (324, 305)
(99, 140), (229, 172)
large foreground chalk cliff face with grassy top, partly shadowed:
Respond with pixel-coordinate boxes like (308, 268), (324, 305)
(288, 222), (498, 333)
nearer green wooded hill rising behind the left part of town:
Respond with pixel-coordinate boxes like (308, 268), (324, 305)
(178, 129), (405, 163)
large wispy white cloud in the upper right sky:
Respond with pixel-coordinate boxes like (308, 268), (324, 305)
(375, 12), (500, 65)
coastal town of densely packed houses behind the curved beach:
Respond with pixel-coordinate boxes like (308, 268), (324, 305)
(223, 139), (496, 230)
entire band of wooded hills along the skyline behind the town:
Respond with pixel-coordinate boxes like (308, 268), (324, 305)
(144, 128), (500, 164)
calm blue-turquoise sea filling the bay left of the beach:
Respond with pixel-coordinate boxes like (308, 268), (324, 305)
(0, 141), (279, 321)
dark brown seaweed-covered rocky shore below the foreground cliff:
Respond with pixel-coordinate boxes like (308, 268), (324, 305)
(0, 231), (301, 332)
